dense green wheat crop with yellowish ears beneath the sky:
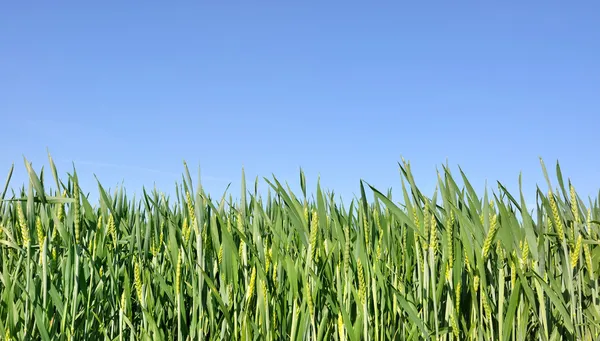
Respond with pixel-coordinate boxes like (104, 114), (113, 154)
(0, 158), (600, 340)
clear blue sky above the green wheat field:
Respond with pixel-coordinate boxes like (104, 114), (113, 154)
(0, 1), (600, 205)
